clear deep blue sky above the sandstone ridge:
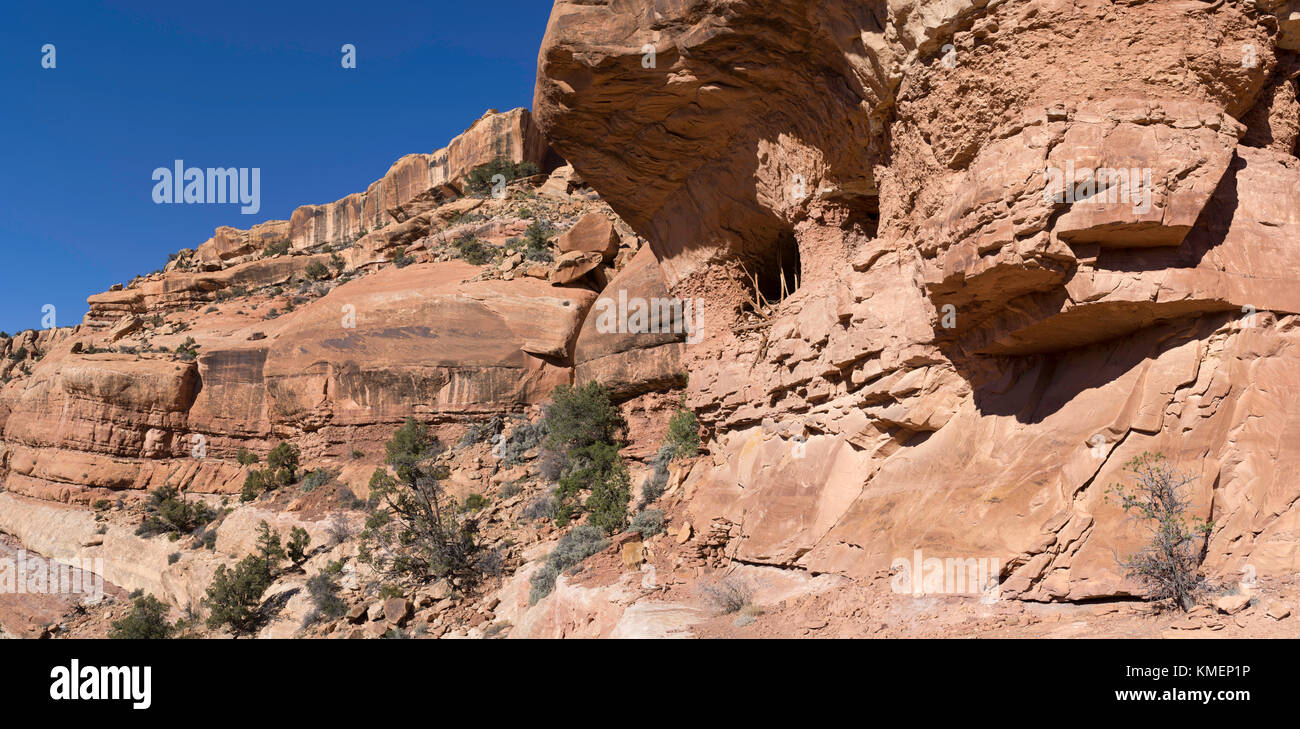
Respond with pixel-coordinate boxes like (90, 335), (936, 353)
(0, 0), (551, 334)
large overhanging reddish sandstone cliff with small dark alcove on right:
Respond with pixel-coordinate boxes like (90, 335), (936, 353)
(534, 0), (1300, 600)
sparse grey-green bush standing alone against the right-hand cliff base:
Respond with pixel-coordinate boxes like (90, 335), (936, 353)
(1106, 452), (1214, 611)
